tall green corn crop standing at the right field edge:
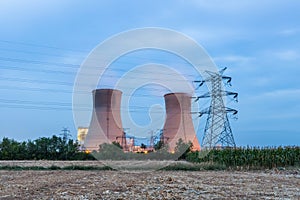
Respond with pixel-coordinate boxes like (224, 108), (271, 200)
(187, 146), (300, 169)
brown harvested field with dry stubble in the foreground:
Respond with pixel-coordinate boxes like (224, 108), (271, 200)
(0, 161), (300, 199)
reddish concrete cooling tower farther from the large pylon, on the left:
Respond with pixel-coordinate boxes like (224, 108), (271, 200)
(84, 89), (123, 151)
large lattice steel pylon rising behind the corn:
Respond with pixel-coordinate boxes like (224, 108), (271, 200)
(195, 68), (238, 149)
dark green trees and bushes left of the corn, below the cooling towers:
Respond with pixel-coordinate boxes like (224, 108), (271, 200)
(0, 135), (192, 160)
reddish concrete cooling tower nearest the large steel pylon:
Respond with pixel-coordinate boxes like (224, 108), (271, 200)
(163, 93), (200, 152)
